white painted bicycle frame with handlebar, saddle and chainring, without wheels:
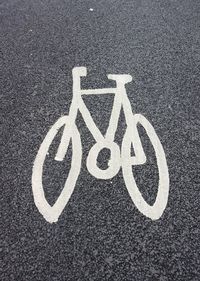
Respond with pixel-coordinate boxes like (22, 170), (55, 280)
(55, 67), (146, 175)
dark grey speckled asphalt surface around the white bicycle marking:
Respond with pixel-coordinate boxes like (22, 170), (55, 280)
(0, 0), (200, 281)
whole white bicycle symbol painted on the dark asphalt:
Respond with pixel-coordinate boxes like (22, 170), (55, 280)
(32, 67), (169, 223)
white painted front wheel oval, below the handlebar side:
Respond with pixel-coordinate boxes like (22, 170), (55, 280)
(32, 116), (82, 223)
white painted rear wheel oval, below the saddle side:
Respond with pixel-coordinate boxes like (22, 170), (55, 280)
(122, 114), (169, 220)
